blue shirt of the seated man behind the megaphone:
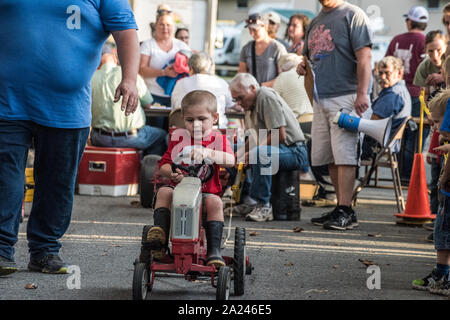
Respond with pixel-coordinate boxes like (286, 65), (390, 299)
(372, 80), (411, 136)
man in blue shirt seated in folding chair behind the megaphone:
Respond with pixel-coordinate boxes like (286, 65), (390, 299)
(361, 56), (411, 160)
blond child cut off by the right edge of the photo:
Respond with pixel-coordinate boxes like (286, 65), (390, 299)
(413, 89), (450, 296)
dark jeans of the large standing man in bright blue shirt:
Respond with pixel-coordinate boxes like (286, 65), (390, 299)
(0, 120), (89, 260)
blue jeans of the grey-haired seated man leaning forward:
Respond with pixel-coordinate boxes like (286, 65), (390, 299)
(249, 142), (309, 204)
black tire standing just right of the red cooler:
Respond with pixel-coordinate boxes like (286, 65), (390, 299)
(139, 154), (161, 208)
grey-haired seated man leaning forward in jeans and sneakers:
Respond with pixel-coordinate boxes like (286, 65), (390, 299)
(230, 73), (309, 221)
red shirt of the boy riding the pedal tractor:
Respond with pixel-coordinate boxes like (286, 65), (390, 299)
(158, 129), (234, 196)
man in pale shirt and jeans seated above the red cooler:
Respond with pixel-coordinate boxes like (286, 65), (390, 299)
(91, 52), (166, 155)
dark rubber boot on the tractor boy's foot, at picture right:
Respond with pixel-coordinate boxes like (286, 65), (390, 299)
(206, 221), (225, 269)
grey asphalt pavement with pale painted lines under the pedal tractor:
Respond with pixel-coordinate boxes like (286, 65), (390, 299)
(0, 181), (447, 300)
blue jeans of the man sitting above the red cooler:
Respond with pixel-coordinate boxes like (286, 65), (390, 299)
(91, 126), (167, 156)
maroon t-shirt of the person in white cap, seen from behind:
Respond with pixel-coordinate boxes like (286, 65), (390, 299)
(386, 32), (425, 97)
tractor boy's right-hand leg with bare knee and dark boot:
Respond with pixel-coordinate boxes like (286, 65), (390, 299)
(203, 194), (225, 268)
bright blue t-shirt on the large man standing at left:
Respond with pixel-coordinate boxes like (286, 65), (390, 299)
(0, 0), (137, 128)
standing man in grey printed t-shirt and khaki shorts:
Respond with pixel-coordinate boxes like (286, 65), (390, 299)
(297, 0), (372, 230)
